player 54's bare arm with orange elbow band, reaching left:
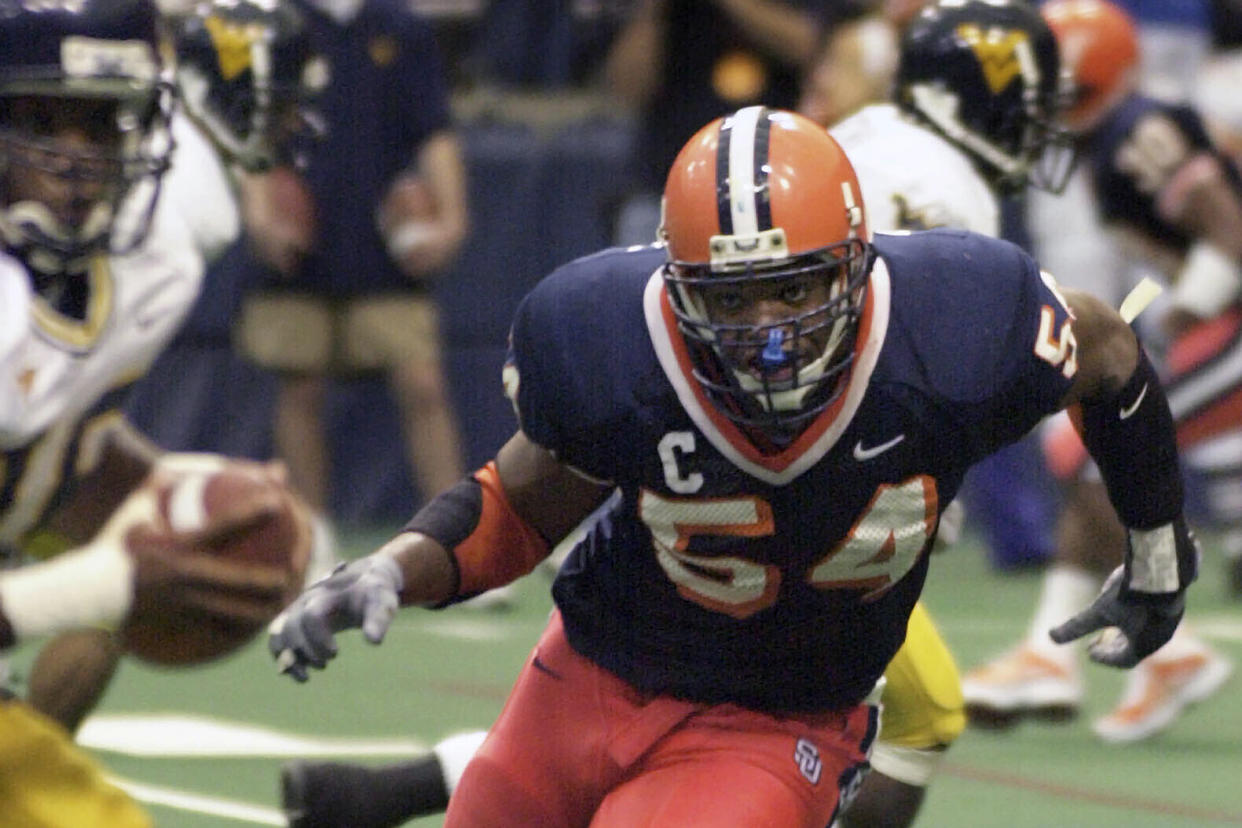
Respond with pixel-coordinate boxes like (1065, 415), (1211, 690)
(268, 431), (609, 682)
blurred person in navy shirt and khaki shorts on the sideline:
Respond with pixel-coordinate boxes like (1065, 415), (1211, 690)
(231, 0), (467, 531)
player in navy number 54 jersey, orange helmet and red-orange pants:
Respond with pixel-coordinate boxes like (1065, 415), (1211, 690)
(270, 107), (1197, 828)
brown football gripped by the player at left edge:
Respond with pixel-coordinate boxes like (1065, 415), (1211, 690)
(120, 458), (311, 667)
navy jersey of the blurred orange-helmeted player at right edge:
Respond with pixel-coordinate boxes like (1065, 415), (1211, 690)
(1087, 94), (1240, 253)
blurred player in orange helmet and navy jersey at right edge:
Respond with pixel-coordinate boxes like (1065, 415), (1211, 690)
(963, 0), (1242, 742)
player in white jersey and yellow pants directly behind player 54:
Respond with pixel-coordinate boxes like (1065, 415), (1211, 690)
(281, 6), (1063, 828)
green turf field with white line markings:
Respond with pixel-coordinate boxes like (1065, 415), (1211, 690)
(15, 534), (1242, 828)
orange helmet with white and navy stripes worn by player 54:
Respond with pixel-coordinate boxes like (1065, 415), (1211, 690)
(660, 107), (872, 436)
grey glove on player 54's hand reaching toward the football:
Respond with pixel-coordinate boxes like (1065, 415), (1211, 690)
(267, 555), (402, 682)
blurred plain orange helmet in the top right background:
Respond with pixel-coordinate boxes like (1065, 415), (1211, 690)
(1040, 0), (1139, 132)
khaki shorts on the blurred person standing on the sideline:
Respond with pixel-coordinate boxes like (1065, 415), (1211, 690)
(235, 292), (440, 374)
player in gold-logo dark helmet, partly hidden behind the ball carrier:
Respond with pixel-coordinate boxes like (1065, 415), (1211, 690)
(9, 0), (334, 732)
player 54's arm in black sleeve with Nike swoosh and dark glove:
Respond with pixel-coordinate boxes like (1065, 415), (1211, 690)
(1051, 290), (1199, 667)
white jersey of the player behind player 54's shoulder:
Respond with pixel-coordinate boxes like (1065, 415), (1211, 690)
(828, 103), (1000, 237)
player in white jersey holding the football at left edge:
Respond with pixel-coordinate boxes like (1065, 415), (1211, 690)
(0, 0), (315, 827)
